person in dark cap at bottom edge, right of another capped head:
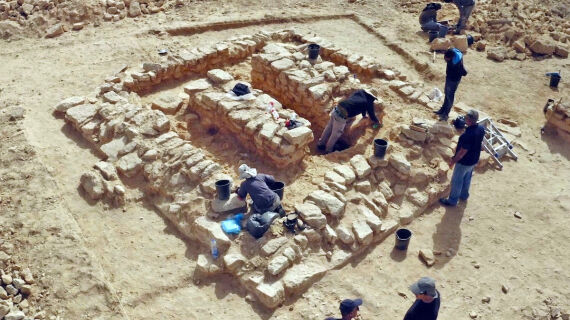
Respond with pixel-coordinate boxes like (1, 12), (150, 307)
(404, 277), (440, 320)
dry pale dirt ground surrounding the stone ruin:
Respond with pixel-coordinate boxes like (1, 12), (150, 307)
(0, 1), (570, 320)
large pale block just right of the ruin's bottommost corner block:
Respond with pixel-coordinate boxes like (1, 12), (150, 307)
(283, 261), (327, 295)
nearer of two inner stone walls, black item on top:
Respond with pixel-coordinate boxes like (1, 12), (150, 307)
(185, 69), (314, 168)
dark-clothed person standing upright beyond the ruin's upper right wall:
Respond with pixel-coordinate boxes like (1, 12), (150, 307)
(434, 48), (467, 121)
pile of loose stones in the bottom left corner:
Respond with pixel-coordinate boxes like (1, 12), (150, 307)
(0, 268), (38, 320)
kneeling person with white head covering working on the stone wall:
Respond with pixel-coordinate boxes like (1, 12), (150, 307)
(236, 164), (285, 216)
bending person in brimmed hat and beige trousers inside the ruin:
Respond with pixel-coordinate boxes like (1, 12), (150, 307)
(317, 89), (380, 153)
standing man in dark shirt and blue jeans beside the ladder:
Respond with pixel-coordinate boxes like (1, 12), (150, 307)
(439, 109), (485, 206)
